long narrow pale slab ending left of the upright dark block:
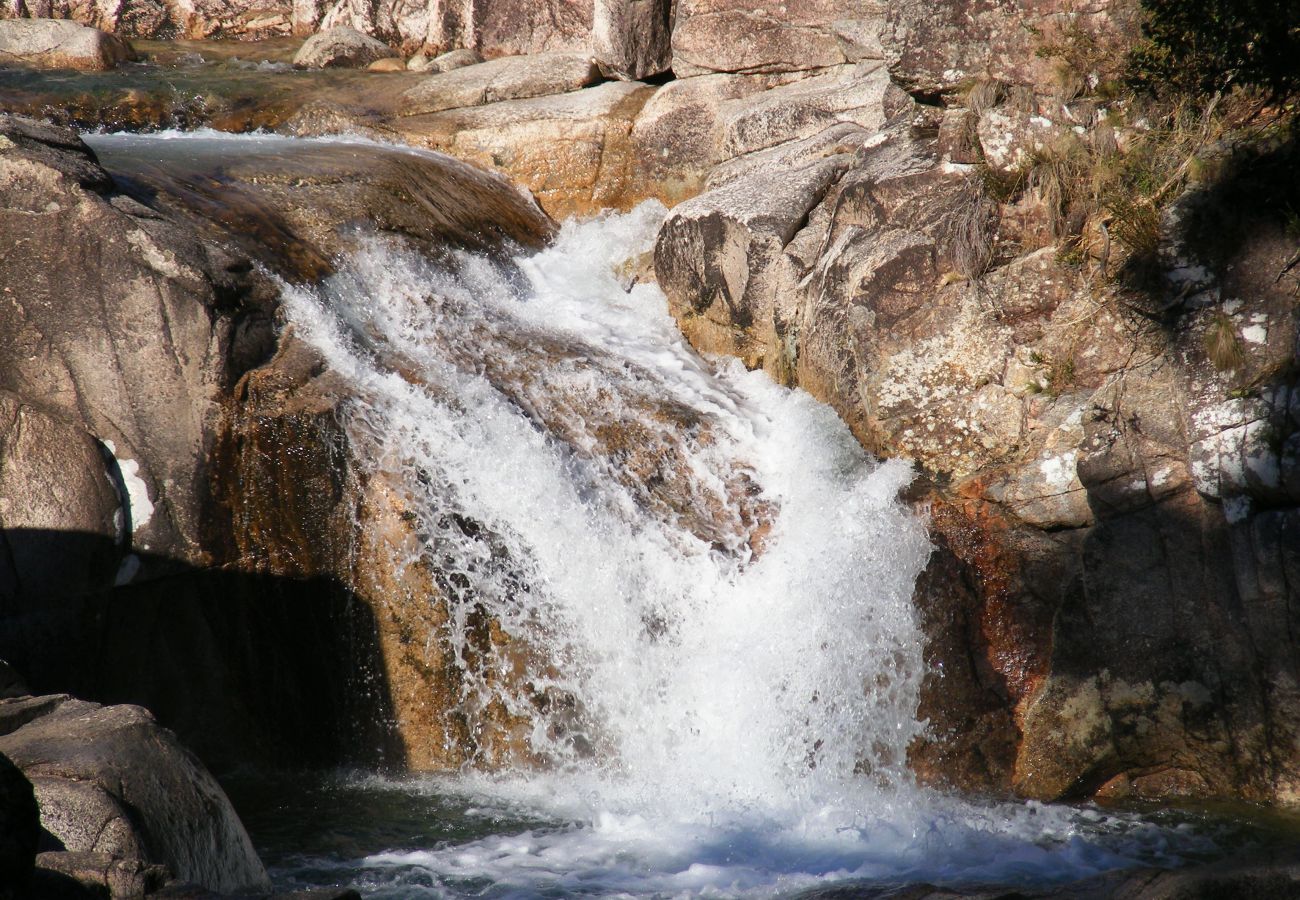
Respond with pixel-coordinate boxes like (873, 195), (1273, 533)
(402, 53), (601, 116)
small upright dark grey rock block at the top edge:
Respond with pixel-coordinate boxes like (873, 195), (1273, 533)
(592, 0), (672, 81)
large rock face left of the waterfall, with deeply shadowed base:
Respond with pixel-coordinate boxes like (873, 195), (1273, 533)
(0, 110), (554, 780)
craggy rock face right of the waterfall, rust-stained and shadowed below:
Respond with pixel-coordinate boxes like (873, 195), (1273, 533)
(647, 61), (1300, 802)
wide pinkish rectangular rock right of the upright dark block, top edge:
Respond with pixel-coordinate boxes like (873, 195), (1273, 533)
(672, 0), (884, 77)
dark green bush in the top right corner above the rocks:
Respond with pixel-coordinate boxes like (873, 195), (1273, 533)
(1128, 0), (1300, 100)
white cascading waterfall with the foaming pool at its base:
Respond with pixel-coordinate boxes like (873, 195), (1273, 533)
(94, 135), (1237, 897)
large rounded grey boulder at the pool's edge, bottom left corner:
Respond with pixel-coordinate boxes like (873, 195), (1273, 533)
(0, 697), (269, 892)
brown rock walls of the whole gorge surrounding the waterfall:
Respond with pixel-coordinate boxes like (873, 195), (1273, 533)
(0, 0), (1300, 896)
